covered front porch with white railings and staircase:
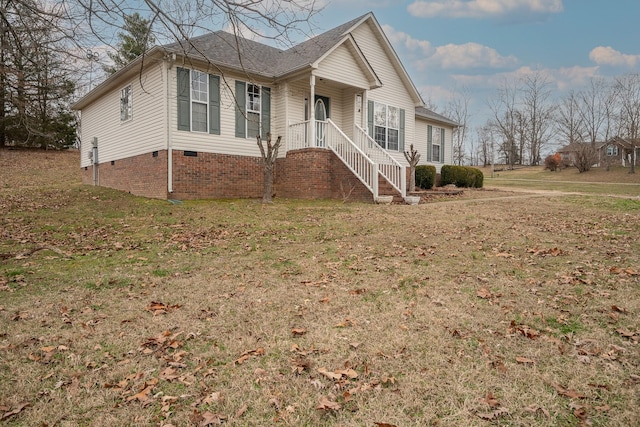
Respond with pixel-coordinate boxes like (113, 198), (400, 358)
(284, 73), (407, 202)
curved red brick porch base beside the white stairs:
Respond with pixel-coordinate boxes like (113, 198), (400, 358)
(275, 148), (373, 203)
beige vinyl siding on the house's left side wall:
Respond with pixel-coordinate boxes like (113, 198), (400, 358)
(80, 63), (167, 167)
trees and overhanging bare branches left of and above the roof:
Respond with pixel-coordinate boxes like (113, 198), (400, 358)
(0, 0), (319, 148)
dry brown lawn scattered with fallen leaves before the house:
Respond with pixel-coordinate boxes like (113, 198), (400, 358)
(0, 153), (640, 426)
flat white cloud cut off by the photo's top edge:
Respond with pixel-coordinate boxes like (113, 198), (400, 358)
(407, 0), (563, 19)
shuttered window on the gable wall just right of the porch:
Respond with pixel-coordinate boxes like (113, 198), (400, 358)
(368, 101), (404, 151)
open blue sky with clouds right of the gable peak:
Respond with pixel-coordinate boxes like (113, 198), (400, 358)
(314, 0), (640, 136)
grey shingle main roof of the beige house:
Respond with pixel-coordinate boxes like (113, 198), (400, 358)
(163, 14), (368, 77)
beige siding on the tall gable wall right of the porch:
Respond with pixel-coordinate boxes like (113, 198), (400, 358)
(353, 22), (416, 165)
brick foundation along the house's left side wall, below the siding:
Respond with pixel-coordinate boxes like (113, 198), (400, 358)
(82, 151), (167, 199)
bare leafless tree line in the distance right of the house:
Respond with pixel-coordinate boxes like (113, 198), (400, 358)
(448, 71), (640, 173)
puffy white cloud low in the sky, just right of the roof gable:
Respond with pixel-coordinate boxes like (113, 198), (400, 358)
(426, 43), (518, 70)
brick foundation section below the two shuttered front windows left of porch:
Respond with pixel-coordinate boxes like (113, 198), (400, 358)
(169, 150), (264, 200)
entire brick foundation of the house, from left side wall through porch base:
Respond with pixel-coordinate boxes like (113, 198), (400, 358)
(82, 148), (380, 203)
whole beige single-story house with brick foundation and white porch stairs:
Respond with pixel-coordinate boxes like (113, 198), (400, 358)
(74, 13), (457, 201)
